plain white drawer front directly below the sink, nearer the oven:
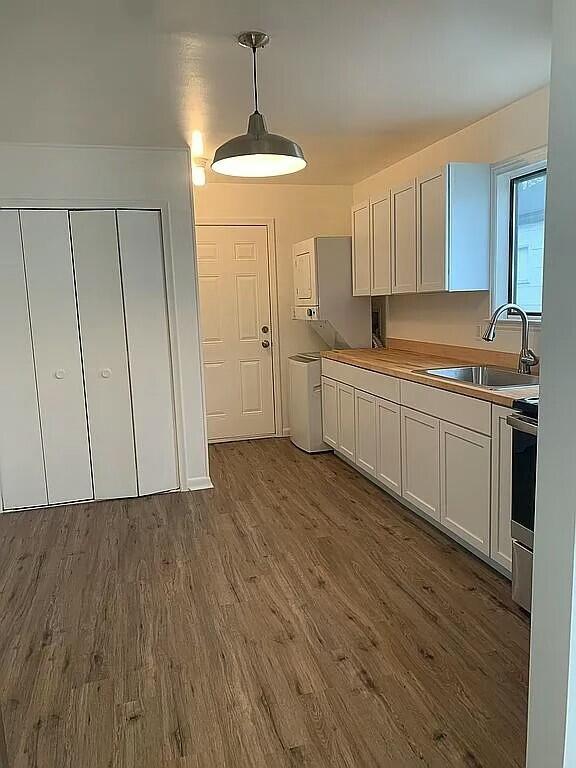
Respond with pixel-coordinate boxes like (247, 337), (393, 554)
(400, 381), (492, 435)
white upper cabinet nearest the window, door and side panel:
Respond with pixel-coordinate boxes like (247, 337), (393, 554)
(416, 163), (490, 293)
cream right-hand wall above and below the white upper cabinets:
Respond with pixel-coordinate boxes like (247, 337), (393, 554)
(353, 89), (548, 352)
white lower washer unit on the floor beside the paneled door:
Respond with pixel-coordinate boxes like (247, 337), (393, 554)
(288, 354), (331, 453)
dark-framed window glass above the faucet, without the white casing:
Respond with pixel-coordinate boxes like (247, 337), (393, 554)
(508, 169), (546, 315)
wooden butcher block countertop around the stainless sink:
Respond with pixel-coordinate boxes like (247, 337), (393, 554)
(322, 345), (539, 408)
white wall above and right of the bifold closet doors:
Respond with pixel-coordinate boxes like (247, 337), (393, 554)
(0, 144), (208, 486)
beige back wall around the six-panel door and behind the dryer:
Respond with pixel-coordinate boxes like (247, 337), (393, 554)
(194, 183), (352, 427)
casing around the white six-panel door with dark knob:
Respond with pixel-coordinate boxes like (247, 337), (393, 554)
(194, 217), (286, 443)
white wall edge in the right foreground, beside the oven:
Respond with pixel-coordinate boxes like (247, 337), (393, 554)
(527, 0), (576, 768)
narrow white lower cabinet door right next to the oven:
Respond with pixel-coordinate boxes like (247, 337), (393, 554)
(490, 405), (514, 571)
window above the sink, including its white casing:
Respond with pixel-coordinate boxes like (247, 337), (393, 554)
(492, 150), (547, 321)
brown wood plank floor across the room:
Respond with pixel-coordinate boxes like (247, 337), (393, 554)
(0, 440), (529, 768)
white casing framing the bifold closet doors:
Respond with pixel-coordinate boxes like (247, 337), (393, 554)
(0, 198), (194, 498)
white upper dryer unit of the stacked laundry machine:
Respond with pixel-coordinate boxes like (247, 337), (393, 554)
(292, 237), (372, 348)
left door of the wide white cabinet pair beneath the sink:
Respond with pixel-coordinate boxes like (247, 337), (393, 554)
(401, 408), (440, 520)
